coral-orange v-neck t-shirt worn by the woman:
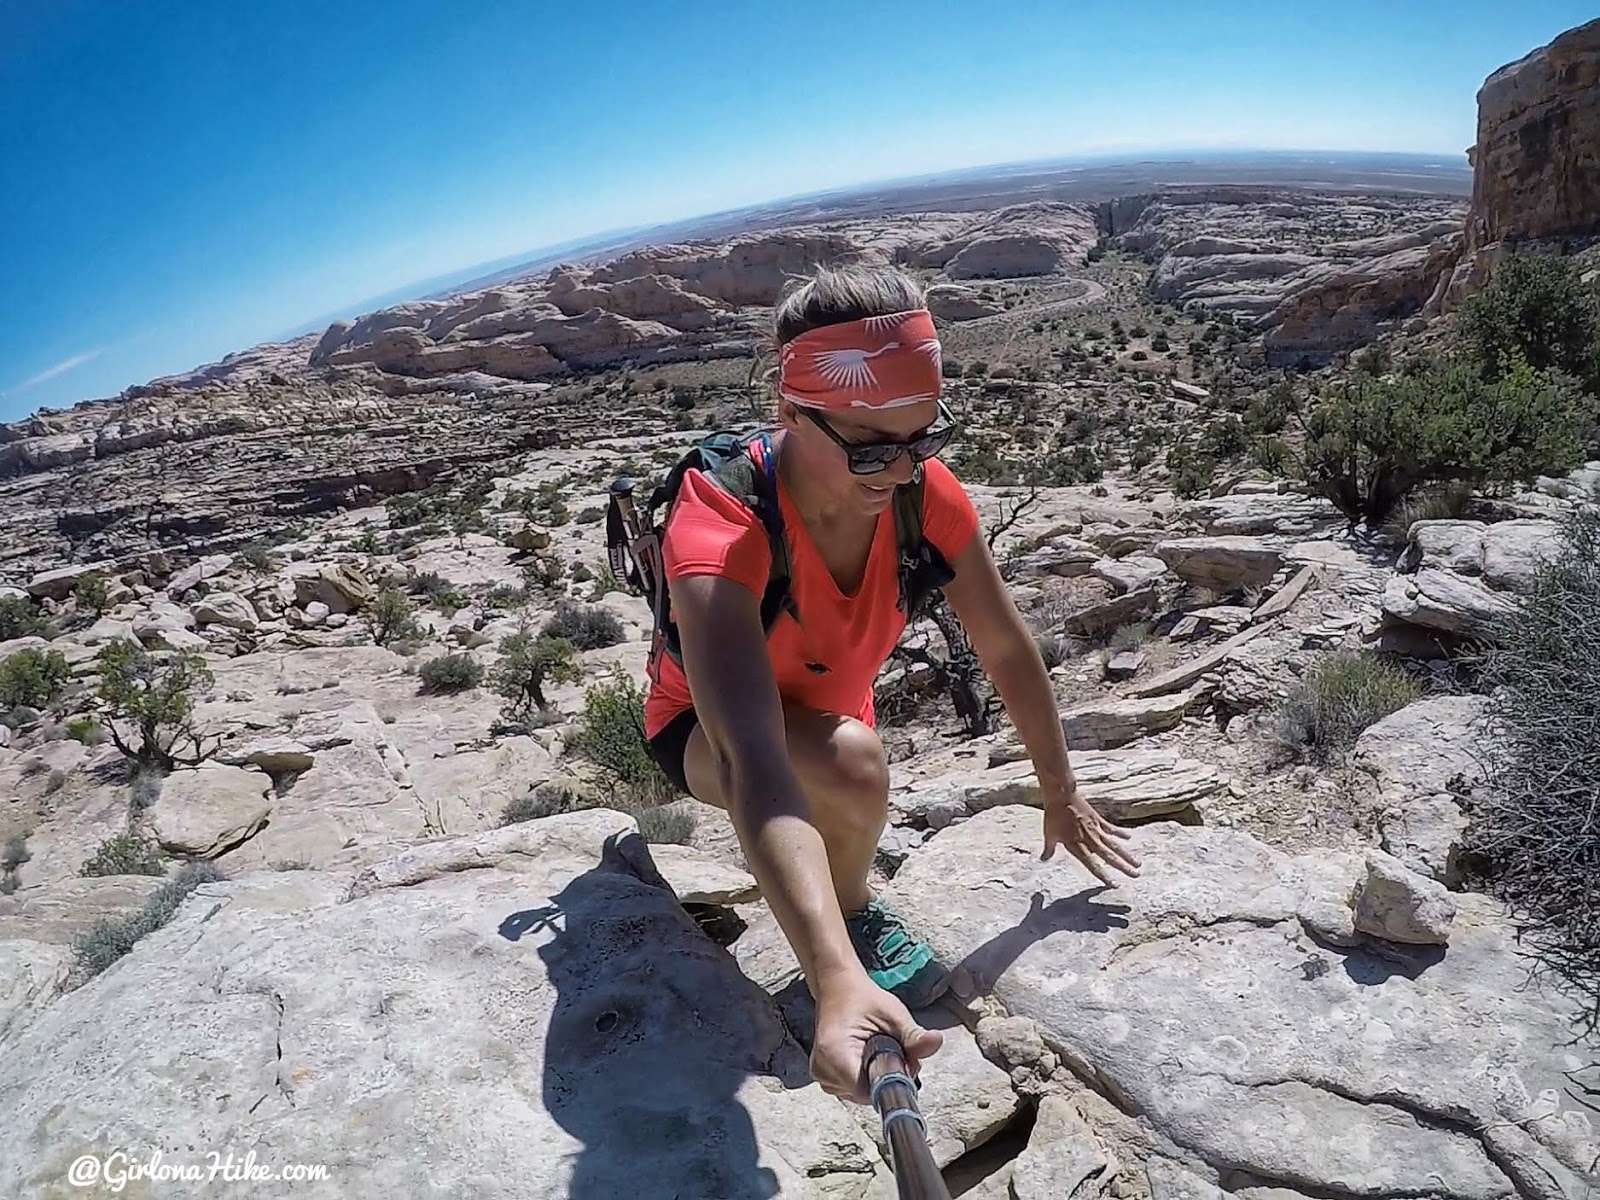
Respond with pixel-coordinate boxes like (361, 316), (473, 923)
(645, 448), (978, 738)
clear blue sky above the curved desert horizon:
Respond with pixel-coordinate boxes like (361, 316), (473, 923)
(0, 0), (1594, 419)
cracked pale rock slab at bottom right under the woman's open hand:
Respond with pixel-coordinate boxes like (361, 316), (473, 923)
(890, 808), (1600, 1200)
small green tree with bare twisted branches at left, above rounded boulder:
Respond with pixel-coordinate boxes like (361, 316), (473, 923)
(94, 640), (214, 771)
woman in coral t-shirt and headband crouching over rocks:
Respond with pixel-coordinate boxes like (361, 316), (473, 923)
(645, 267), (1139, 1102)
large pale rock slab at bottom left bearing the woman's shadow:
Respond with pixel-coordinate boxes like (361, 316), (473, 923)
(0, 810), (893, 1200)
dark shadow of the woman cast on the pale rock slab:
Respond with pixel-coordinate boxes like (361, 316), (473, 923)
(499, 834), (796, 1200)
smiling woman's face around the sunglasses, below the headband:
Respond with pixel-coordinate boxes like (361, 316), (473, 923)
(779, 400), (939, 514)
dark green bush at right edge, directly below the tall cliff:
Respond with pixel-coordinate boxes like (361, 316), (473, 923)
(1459, 254), (1600, 390)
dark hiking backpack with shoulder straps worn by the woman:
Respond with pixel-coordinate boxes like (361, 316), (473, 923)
(606, 430), (955, 666)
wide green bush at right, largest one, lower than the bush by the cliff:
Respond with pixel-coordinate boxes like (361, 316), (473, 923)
(1304, 352), (1595, 528)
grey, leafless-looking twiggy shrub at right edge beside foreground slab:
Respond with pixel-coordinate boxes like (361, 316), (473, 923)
(1469, 512), (1600, 1027)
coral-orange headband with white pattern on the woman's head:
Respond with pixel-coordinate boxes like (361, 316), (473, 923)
(778, 309), (941, 408)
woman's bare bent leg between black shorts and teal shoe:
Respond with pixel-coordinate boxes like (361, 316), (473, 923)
(683, 704), (890, 914)
